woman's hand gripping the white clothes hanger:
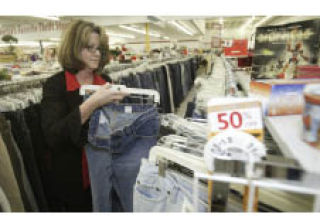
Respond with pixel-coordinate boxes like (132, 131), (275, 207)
(89, 84), (129, 108)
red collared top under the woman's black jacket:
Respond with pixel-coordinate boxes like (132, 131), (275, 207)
(65, 71), (106, 189)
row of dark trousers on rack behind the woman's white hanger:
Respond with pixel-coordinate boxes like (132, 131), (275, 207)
(105, 56), (201, 113)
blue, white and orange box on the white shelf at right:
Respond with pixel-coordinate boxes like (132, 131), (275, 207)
(249, 79), (320, 116)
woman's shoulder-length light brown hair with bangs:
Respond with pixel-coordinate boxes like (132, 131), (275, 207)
(58, 20), (109, 74)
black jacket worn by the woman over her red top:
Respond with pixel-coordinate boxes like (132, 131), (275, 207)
(41, 71), (109, 211)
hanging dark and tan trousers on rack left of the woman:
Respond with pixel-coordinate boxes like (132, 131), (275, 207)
(0, 75), (50, 212)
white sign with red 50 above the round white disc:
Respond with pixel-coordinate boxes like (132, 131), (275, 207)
(208, 98), (263, 141)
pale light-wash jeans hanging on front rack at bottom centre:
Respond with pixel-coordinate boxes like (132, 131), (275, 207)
(133, 159), (208, 212)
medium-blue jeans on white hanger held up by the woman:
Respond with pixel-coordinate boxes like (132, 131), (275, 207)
(85, 104), (160, 212)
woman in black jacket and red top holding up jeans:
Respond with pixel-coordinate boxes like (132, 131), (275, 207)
(41, 21), (126, 211)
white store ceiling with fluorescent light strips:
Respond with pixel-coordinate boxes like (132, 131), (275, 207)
(0, 16), (320, 43)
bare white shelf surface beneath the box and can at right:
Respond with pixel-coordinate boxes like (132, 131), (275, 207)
(265, 115), (320, 173)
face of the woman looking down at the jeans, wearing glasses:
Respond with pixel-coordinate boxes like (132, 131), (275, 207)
(81, 33), (101, 69)
